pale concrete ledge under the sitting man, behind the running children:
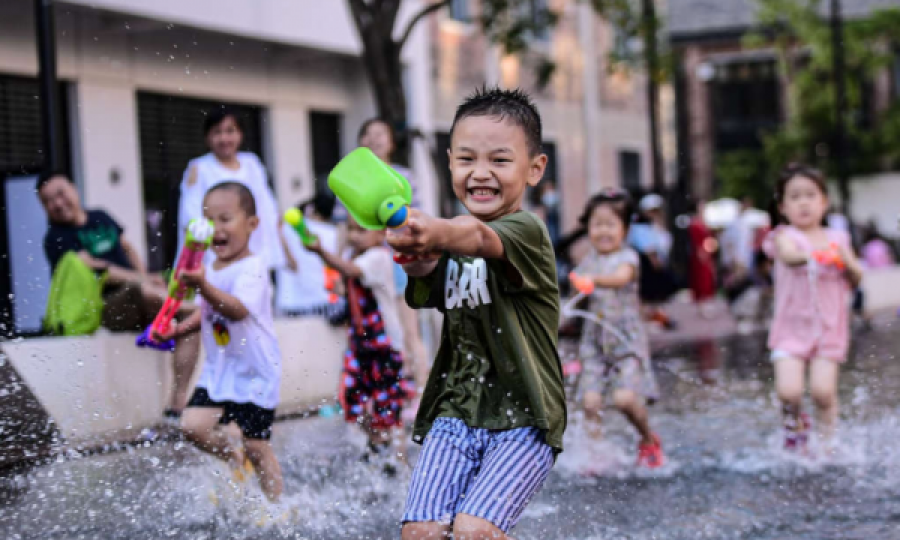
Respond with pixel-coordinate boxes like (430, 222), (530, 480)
(0, 318), (347, 450)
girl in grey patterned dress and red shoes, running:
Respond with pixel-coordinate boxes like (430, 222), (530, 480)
(573, 190), (665, 468)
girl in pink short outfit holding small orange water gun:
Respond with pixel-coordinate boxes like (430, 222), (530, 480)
(764, 165), (862, 451)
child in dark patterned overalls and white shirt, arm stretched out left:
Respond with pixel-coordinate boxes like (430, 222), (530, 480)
(309, 218), (409, 474)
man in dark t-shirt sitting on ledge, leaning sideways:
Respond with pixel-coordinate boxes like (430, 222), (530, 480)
(36, 173), (200, 418)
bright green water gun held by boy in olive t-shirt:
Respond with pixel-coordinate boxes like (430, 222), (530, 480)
(328, 147), (416, 264)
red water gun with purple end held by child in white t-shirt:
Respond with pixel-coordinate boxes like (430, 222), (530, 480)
(137, 219), (215, 351)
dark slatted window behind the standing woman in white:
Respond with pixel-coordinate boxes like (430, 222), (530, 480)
(137, 92), (264, 271)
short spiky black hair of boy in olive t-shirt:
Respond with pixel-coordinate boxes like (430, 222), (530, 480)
(450, 86), (543, 156)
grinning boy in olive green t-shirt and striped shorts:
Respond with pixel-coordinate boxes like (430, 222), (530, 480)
(388, 89), (566, 539)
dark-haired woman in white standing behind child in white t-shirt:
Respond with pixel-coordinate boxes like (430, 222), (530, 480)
(177, 107), (284, 269)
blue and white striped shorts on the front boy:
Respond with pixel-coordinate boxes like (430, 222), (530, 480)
(403, 418), (555, 533)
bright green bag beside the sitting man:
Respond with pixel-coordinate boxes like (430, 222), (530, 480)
(44, 251), (106, 336)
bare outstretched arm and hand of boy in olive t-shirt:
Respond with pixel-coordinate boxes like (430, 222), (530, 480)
(388, 209), (506, 260)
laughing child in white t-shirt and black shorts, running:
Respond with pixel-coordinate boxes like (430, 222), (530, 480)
(159, 182), (282, 501)
